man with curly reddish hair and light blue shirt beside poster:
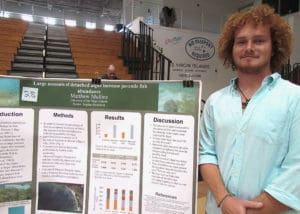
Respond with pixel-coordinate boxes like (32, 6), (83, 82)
(199, 5), (300, 214)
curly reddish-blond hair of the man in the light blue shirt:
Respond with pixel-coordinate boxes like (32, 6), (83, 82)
(218, 4), (293, 71)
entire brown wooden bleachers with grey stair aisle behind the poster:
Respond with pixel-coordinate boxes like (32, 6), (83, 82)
(0, 18), (134, 80)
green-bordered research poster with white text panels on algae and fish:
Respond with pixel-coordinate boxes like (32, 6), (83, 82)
(0, 76), (202, 214)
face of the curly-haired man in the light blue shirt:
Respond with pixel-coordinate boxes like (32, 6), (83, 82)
(232, 23), (272, 73)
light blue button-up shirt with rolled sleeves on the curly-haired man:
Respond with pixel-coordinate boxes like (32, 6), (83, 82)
(199, 73), (300, 214)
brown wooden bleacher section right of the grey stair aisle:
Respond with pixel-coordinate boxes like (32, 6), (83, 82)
(66, 27), (134, 80)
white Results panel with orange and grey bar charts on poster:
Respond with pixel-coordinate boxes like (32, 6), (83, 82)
(89, 111), (141, 214)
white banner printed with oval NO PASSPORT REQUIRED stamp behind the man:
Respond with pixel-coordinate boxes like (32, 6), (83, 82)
(151, 26), (235, 99)
